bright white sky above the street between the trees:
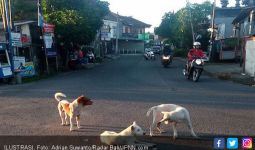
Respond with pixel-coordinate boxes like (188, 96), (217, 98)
(104, 0), (235, 32)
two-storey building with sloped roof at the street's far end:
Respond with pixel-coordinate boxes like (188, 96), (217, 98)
(101, 12), (151, 54)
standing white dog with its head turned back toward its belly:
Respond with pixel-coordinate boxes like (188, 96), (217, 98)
(147, 104), (197, 139)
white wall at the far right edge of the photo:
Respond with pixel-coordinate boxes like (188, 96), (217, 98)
(245, 39), (255, 77)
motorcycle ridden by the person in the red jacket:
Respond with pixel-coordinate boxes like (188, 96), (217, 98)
(183, 58), (205, 82)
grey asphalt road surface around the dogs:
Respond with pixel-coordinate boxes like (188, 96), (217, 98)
(0, 56), (255, 149)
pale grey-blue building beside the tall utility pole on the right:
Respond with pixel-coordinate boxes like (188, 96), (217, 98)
(210, 4), (242, 61)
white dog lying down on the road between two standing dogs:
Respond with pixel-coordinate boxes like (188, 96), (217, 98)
(100, 122), (145, 145)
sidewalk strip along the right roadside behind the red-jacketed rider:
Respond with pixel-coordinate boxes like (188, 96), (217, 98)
(177, 58), (255, 86)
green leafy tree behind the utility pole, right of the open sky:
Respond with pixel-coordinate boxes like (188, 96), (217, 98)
(155, 1), (211, 48)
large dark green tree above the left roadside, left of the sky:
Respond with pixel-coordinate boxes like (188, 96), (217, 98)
(42, 0), (109, 45)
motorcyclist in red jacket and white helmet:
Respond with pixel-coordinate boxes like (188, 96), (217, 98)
(186, 42), (205, 73)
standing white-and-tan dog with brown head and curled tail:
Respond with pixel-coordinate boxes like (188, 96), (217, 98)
(55, 93), (93, 131)
